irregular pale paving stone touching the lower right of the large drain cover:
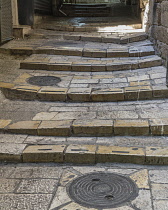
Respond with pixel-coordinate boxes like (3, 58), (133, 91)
(131, 190), (152, 210)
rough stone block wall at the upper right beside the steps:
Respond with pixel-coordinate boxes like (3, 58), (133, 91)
(148, 0), (168, 67)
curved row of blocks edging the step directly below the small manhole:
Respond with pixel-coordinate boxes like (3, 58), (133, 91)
(0, 82), (168, 102)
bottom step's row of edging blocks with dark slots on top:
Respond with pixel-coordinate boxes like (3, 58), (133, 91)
(0, 144), (168, 165)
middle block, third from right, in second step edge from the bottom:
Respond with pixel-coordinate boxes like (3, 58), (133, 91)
(72, 120), (113, 136)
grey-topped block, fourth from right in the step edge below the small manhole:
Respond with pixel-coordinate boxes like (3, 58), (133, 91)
(68, 88), (91, 101)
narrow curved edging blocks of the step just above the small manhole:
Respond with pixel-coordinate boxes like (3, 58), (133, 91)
(20, 54), (162, 72)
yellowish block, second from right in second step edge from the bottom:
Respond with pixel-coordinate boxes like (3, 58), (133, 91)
(114, 120), (149, 136)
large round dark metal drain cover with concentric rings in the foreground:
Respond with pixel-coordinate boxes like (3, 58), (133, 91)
(67, 173), (138, 208)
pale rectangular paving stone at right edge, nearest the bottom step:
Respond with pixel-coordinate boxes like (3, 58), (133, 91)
(149, 170), (168, 184)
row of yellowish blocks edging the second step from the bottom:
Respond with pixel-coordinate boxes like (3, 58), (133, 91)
(0, 118), (168, 137)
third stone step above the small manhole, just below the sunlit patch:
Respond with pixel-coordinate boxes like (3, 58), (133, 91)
(29, 29), (146, 45)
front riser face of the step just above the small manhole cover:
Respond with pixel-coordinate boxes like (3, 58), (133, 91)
(20, 59), (162, 72)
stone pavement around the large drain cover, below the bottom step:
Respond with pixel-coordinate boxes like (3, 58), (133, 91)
(0, 164), (168, 210)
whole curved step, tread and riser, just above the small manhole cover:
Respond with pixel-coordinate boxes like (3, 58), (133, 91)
(20, 54), (162, 72)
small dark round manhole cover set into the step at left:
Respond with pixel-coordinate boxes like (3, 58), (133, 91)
(27, 76), (61, 86)
